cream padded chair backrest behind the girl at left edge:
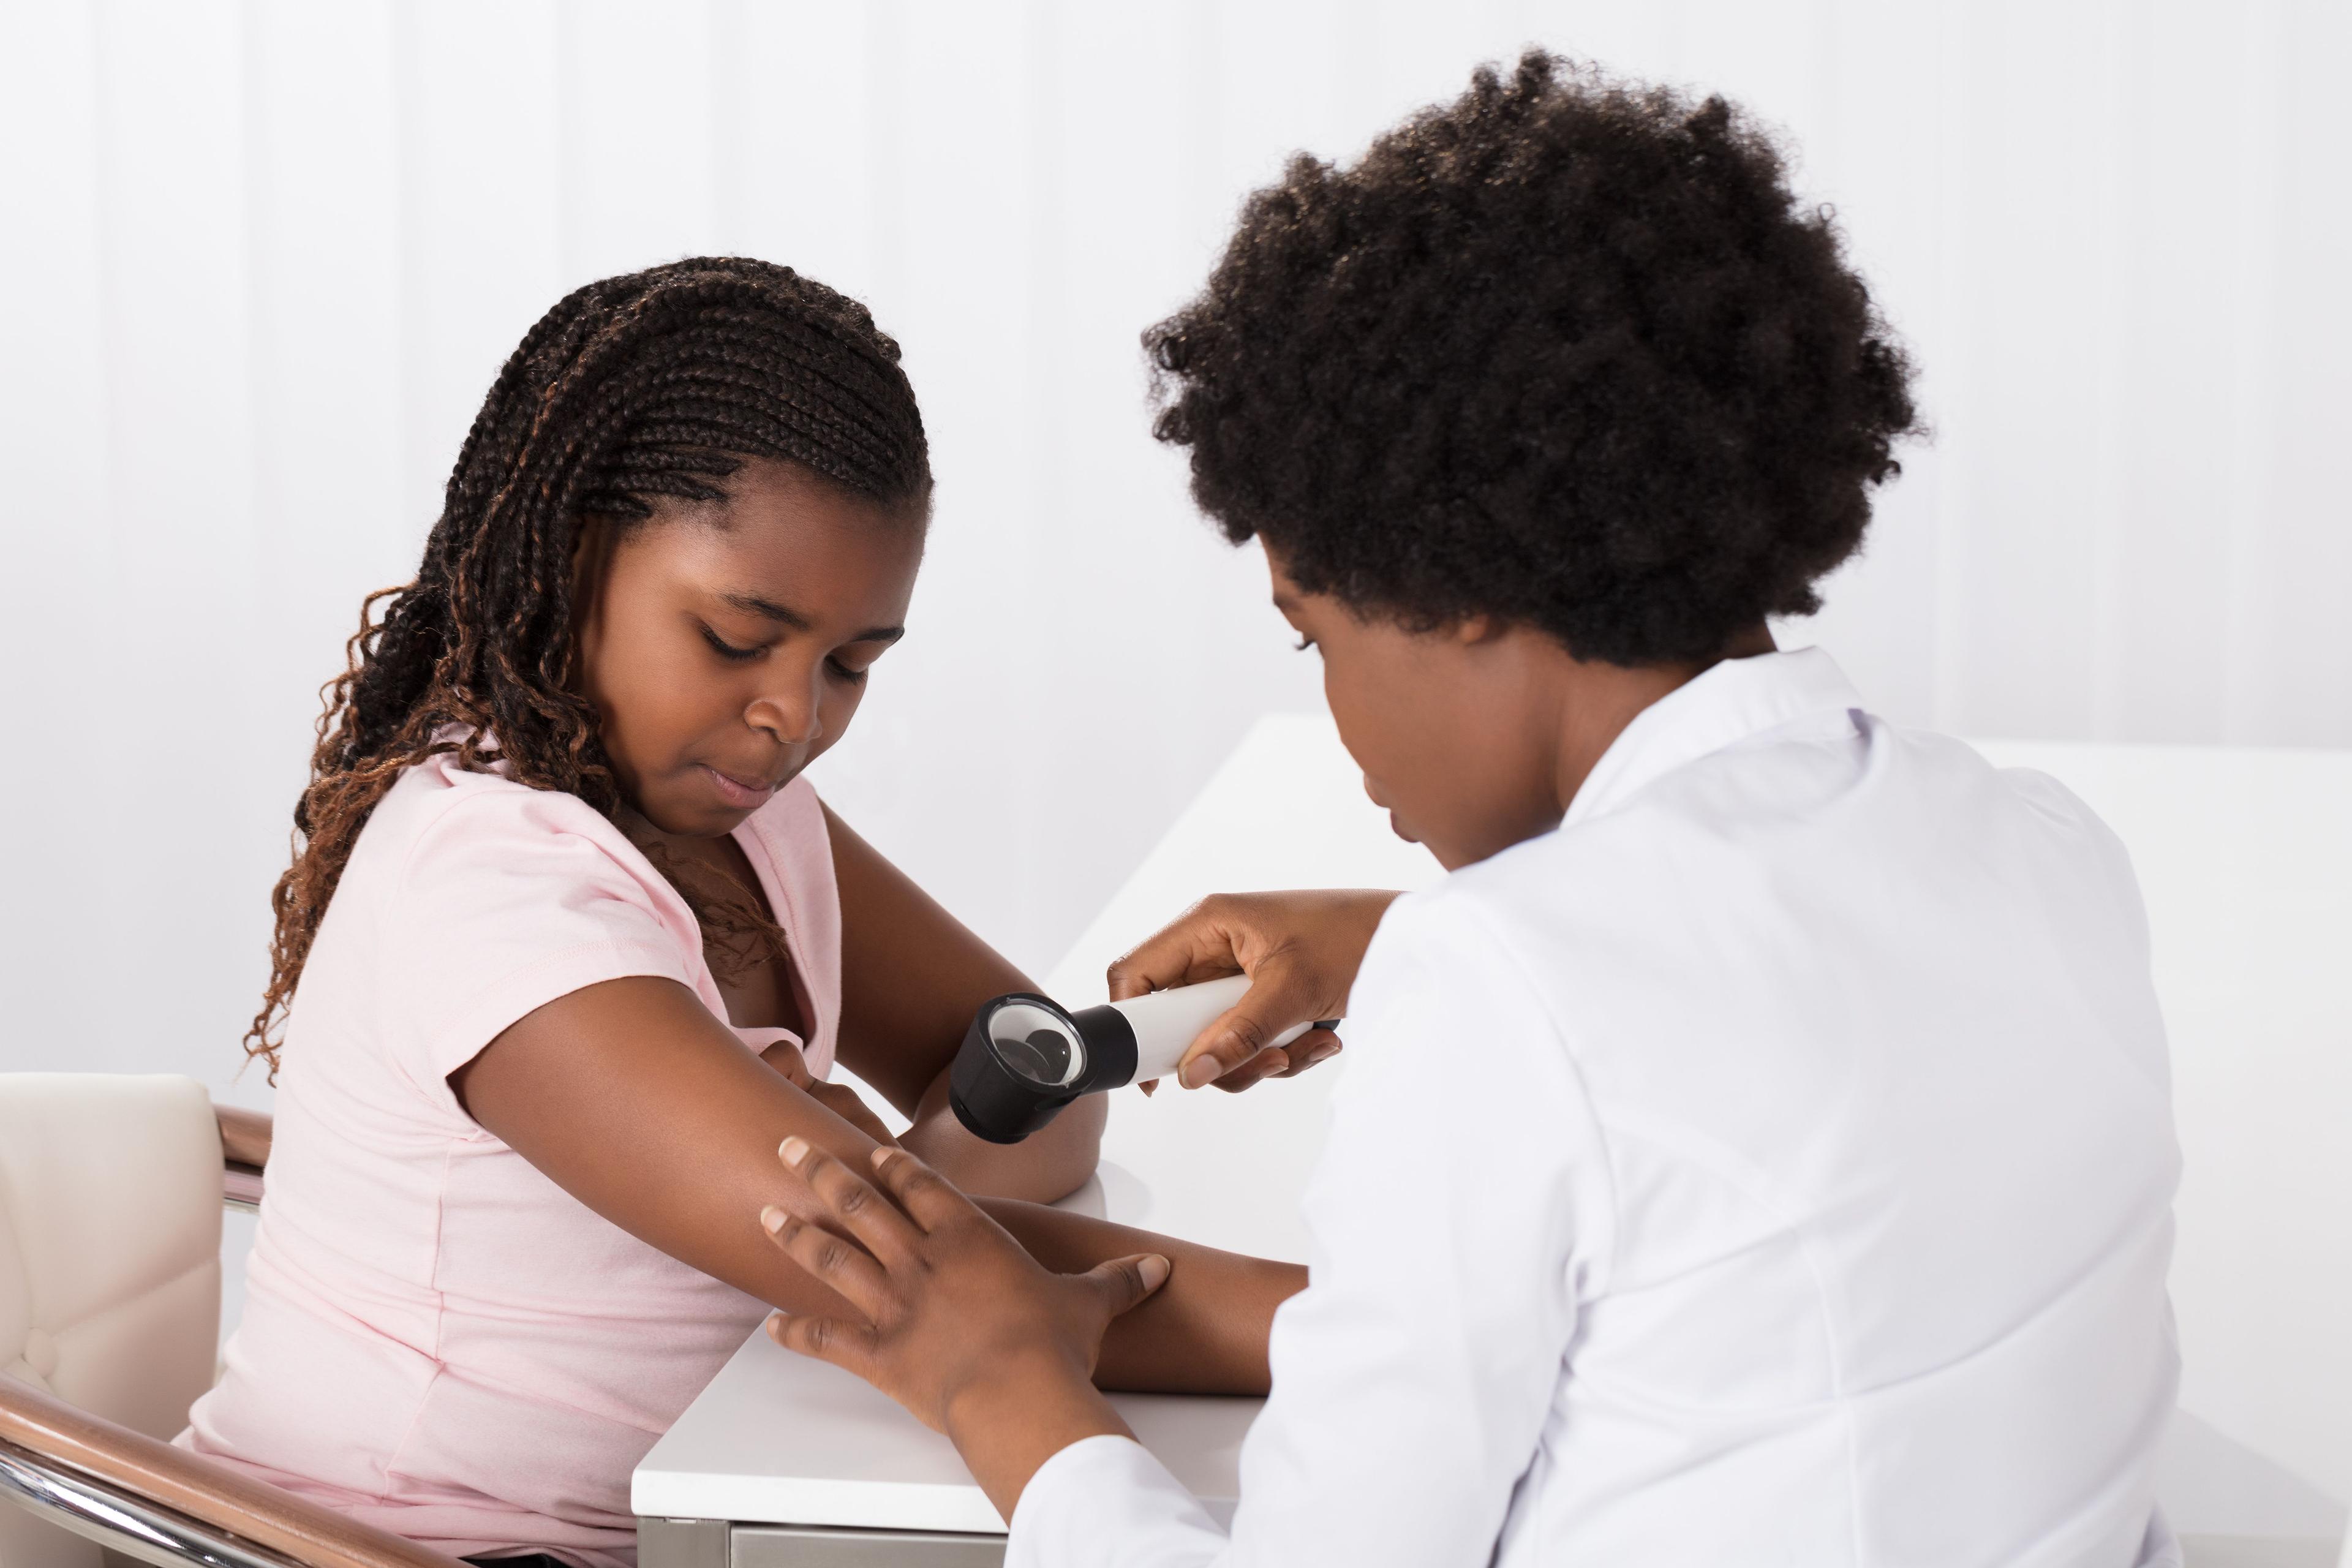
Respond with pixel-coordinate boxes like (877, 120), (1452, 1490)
(0, 1072), (221, 1568)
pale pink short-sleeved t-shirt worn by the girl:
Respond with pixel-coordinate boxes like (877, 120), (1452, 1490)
(179, 757), (842, 1566)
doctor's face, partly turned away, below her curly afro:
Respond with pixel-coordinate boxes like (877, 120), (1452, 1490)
(1261, 536), (1562, 870)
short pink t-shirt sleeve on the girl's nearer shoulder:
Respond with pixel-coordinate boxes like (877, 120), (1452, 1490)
(379, 776), (698, 1098)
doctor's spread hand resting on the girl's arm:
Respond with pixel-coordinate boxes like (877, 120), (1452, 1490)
(760, 1138), (1169, 1518)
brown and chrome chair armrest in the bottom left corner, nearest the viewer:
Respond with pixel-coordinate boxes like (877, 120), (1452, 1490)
(0, 1378), (463, 1568)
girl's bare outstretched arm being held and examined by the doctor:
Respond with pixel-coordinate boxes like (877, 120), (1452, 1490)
(449, 976), (1305, 1394)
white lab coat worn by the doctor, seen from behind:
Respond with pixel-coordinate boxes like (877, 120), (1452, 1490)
(1007, 651), (2178, 1568)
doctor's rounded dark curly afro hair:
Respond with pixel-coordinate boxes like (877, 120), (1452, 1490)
(1143, 51), (1917, 665)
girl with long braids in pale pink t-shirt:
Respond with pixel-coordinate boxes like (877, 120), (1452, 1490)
(181, 261), (1336, 1563)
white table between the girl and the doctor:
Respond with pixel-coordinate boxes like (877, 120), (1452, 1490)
(633, 715), (2352, 1568)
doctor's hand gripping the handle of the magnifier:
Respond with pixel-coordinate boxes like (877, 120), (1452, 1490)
(1110, 889), (1400, 1091)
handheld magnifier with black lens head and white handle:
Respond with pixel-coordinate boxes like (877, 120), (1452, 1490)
(948, 976), (1338, 1142)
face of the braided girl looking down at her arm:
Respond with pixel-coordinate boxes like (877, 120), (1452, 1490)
(574, 458), (924, 837)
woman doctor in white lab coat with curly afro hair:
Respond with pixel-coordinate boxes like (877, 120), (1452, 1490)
(762, 54), (2178, 1568)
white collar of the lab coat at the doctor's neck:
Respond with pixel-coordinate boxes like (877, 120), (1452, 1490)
(1559, 649), (1863, 827)
